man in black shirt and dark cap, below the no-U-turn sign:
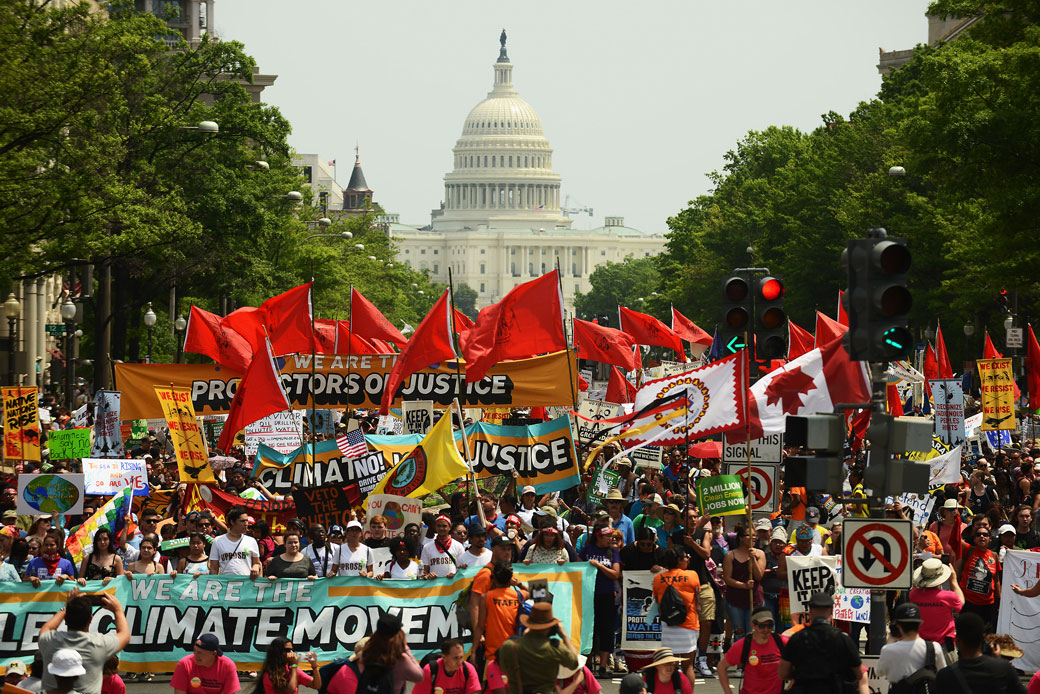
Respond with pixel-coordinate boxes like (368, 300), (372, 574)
(777, 591), (869, 694)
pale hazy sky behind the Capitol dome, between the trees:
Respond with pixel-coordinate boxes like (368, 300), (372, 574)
(214, 0), (929, 232)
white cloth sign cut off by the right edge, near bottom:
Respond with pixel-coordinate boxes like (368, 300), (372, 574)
(996, 549), (1040, 672)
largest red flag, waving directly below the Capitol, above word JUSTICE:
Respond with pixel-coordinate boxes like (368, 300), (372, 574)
(459, 271), (567, 383)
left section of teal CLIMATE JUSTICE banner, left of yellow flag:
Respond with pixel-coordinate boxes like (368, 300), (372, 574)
(253, 440), (391, 497)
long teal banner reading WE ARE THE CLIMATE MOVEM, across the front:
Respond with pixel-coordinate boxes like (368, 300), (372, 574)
(0, 562), (596, 672)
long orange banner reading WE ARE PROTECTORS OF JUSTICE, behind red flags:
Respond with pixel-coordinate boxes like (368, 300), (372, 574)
(115, 352), (577, 419)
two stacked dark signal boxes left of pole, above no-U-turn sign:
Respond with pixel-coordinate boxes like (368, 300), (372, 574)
(784, 414), (846, 494)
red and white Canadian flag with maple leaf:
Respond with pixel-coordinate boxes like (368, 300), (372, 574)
(736, 337), (870, 440)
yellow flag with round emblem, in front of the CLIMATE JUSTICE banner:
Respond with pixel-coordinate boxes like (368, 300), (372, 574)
(371, 407), (469, 496)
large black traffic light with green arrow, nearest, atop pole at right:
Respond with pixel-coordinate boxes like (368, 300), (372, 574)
(841, 229), (913, 362)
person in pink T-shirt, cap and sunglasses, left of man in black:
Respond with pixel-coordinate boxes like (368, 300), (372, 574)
(719, 606), (787, 694)
